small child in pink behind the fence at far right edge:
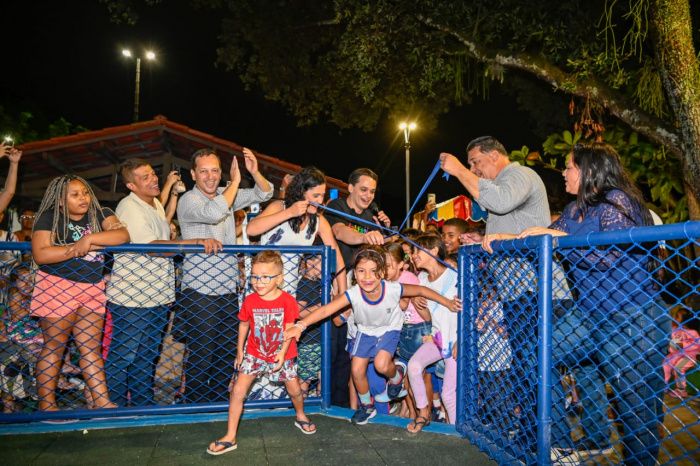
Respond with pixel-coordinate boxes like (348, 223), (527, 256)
(664, 311), (700, 399)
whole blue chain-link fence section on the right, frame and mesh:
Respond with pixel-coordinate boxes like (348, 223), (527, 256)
(456, 222), (700, 464)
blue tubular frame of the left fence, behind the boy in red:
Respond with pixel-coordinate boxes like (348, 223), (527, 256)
(0, 242), (335, 431)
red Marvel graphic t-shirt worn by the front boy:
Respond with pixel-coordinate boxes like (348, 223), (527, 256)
(238, 291), (299, 362)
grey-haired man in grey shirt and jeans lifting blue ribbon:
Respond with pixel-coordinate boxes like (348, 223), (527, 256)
(440, 136), (590, 456)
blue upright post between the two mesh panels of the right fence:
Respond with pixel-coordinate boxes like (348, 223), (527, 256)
(537, 235), (552, 465)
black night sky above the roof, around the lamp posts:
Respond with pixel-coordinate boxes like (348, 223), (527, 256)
(0, 0), (556, 222)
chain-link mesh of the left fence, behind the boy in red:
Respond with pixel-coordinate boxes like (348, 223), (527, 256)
(0, 243), (330, 420)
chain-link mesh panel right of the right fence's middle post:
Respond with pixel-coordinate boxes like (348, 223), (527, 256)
(552, 230), (700, 464)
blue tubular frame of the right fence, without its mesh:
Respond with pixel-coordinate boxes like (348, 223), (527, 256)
(456, 222), (700, 465)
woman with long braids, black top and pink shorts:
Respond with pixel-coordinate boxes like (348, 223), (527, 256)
(31, 175), (129, 411)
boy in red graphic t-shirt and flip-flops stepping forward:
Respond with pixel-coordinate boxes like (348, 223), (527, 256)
(207, 251), (316, 455)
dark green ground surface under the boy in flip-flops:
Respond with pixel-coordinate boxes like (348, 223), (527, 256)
(0, 414), (495, 466)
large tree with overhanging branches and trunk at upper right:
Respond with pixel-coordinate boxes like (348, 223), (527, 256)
(101, 0), (700, 218)
